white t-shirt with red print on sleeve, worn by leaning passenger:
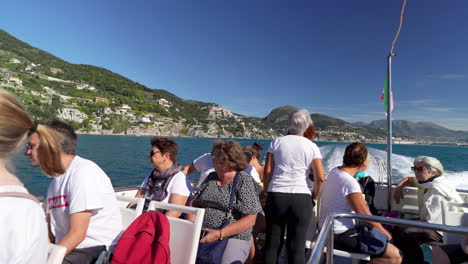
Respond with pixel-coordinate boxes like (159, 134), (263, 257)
(47, 156), (122, 251)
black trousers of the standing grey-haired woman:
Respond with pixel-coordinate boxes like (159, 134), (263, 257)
(264, 192), (313, 264)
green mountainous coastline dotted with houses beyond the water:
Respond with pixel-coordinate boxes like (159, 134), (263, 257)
(0, 30), (468, 141)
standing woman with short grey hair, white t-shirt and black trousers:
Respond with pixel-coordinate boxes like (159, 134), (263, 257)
(263, 109), (324, 263)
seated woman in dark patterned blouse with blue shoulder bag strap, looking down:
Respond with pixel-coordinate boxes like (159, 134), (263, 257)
(189, 141), (261, 263)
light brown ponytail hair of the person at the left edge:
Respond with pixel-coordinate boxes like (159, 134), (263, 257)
(0, 89), (65, 177)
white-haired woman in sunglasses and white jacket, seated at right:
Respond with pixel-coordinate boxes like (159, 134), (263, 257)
(392, 156), (463, 263)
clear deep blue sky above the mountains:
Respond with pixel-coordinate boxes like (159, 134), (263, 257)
(0, 0), (468, 131)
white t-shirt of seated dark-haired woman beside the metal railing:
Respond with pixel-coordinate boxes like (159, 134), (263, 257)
(319, 168), (362, 234)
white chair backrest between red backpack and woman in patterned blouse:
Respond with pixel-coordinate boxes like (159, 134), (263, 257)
(148, 201), (205, 264)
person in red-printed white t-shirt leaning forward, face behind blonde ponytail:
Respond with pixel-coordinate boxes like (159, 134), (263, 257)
(25, 121), (122, 263)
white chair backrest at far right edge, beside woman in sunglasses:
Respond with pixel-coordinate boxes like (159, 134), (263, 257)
(441, 201), (468, 244)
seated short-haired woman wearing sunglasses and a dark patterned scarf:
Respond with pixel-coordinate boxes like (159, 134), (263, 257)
(135, 137), (191, 217)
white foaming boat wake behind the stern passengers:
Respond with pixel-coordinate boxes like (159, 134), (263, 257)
(320, 144), (468, 190)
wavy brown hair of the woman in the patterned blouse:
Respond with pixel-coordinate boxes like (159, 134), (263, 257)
(211, 140), (248, 171)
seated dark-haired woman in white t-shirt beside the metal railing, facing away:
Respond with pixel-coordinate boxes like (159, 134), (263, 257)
(319, 143), (401, 263)
